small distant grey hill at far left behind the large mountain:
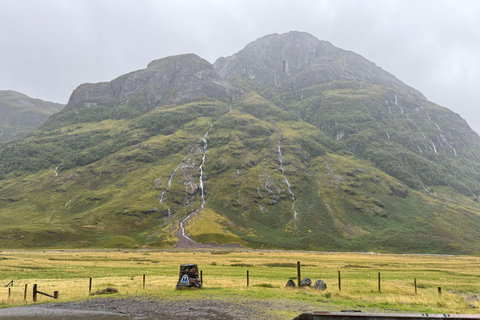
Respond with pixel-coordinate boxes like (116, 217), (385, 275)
(0, 90), (64, 143)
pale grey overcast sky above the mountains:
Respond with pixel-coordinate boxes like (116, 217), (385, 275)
(0, 0), (480, 133)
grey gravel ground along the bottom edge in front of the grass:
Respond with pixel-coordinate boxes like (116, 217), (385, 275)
(0, 297), (322, 320)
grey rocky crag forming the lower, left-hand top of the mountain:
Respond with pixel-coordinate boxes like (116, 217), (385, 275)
(65, 54), (229, 112)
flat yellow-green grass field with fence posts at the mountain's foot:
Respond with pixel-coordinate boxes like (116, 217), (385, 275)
(0, 250), (480, 317)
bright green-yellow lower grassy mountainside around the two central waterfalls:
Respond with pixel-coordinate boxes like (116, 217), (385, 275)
(0, 94), (480, 253)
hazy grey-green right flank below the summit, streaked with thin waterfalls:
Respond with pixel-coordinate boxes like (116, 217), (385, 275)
(273, 81), (480, 195)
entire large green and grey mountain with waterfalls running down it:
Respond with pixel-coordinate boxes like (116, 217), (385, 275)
(0, 32), (480, 253)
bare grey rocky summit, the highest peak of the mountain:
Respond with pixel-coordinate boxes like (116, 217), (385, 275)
(214, 32), (424, 98)
